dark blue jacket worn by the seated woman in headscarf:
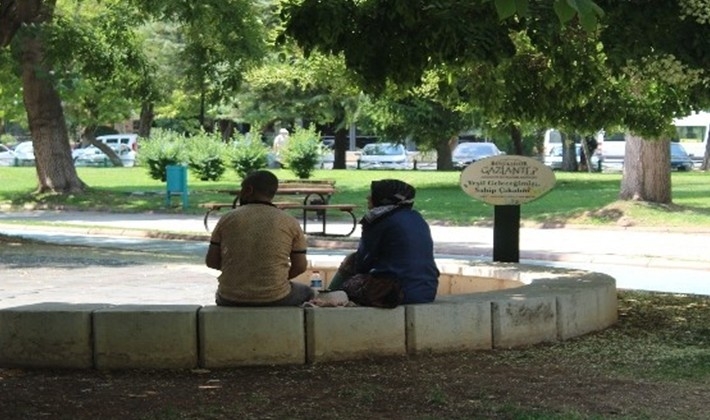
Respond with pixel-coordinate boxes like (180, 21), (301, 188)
(356, 207), (439, 303)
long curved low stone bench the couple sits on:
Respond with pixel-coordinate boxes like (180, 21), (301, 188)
(0, 262), (617, 369)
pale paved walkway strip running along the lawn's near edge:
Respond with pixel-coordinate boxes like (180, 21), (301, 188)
(0, 211), (710, 270)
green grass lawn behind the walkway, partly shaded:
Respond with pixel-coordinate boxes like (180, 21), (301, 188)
(0, 167), (710, 228)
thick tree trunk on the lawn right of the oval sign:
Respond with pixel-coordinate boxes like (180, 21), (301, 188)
(619, 135), (672, 204)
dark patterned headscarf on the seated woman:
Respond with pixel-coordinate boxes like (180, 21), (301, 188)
(360, 179), (417, 225)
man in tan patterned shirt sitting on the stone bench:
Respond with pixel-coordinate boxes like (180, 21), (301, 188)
(205, 170), (314, 306)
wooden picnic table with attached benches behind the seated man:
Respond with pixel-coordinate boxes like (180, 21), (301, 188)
(200, 180), (357, 236)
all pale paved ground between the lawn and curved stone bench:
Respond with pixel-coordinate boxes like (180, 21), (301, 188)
(0, 211), (710, 308)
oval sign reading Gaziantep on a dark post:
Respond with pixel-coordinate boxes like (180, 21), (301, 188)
(460, 155), (555, 263)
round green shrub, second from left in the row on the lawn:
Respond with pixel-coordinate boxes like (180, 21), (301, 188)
(185, 130), (227, 181)
